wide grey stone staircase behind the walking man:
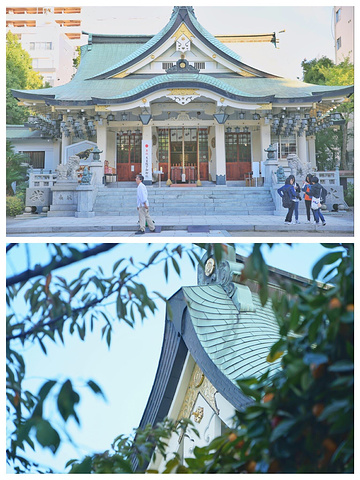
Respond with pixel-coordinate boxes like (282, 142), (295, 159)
(94, 185), (275, 216)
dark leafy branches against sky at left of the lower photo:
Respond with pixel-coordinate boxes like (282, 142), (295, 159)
(6, 243), (208, 473)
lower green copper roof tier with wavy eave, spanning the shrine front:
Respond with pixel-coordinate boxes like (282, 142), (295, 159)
(14, 73), (352, 104)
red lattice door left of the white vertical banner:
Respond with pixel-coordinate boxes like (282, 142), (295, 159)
(116, 130), (142, 182)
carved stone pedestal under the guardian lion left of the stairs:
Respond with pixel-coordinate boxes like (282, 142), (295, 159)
(47, 180), (78, 217)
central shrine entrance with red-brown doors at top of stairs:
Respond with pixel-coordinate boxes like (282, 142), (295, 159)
(158, 127), (209, 183)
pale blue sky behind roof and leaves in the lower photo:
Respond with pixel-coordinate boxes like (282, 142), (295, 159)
(7, 243), (344, 472)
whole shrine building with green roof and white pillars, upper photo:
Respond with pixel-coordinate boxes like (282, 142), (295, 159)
(12, 7), (353, 185)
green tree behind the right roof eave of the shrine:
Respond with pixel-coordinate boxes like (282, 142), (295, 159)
(301, 57), (354, 170)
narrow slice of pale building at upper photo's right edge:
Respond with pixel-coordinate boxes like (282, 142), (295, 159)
(334, 6), (354, 65)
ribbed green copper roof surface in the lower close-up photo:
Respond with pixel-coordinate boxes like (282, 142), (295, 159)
(183, 285), (279, 383)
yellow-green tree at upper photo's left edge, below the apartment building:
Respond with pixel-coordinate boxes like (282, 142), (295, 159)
(6, 31), (43, 125)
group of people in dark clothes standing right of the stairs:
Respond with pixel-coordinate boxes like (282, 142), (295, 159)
(278, 174), (327, 225)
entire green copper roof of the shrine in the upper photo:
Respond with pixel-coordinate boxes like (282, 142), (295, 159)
(13, 7), (353, 105)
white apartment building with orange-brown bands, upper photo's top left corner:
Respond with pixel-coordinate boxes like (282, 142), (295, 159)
(6, 7), (82, 86)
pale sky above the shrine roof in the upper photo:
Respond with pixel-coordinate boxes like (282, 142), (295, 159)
(82, 1), (335, 79)
